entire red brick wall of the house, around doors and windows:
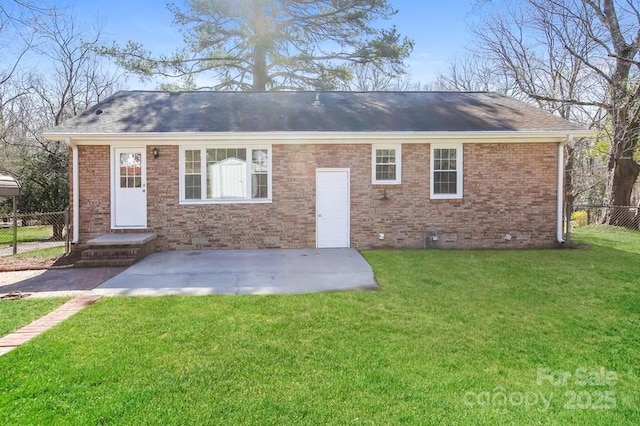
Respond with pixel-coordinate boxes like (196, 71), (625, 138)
(75, 143), (557, 250)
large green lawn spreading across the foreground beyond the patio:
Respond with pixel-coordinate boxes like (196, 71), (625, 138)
(0, 233), (640, 425)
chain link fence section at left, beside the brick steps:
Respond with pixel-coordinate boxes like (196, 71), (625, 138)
(0, 211), (70, 258)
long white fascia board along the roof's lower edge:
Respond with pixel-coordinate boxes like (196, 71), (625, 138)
(43, 130), (595, 145)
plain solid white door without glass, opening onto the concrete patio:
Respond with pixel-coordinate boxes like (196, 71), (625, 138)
(316, 169), (351, 248)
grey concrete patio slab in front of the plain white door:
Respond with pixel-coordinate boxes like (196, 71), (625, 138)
(91, 249), (378, 296)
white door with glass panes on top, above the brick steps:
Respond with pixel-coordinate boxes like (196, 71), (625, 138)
(112, 148), (147, 228)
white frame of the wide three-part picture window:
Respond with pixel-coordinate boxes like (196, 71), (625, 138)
(178, 143), (273, 204)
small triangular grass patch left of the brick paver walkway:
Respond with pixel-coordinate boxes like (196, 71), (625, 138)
(0, 298), (68, 338)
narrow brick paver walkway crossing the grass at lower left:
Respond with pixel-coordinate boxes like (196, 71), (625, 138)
(0, 295), (101, 356)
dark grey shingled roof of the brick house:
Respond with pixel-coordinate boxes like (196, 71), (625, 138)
(46, 91), (585, 138)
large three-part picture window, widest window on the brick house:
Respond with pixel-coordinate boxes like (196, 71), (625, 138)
(180, 146), (271, 203)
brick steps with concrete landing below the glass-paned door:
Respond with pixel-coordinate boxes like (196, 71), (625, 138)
(76, 234), (156, 268)
